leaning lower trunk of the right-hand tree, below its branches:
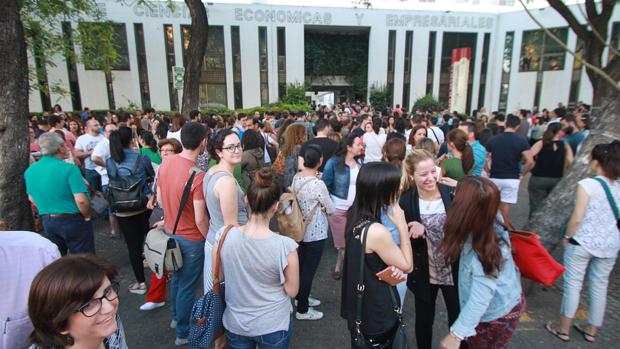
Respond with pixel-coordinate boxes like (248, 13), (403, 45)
(525, 74), (620, 251)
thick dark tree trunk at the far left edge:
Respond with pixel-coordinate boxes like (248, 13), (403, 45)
(0, 0), (32, 230)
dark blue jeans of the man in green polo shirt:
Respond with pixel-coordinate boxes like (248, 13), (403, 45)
(41, 215), (95, 256)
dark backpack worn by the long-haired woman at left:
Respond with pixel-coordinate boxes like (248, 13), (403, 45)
(107, 155), (148, 213)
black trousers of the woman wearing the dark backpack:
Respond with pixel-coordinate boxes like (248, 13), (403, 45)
(116, 210), (151, 282)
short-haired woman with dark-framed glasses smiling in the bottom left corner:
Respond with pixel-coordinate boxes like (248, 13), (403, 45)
(28, 255), (127, 349)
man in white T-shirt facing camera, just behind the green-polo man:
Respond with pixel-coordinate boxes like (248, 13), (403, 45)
(74, 118), (103, 191)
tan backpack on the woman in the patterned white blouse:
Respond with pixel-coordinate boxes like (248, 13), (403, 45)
(276, 179), (320, 242)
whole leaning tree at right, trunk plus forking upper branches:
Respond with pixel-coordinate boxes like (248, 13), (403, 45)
(521, 0), (620, 248)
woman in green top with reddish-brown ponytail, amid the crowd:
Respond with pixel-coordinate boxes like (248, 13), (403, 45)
(441, 128), (474, 181)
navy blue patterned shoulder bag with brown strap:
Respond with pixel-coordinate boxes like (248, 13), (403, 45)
(189, 225), (233, 349)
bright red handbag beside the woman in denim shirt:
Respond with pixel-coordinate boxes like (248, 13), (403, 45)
(504, 224), (564, 287)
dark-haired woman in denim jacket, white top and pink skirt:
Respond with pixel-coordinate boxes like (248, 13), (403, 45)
(322, 134), (364, 280)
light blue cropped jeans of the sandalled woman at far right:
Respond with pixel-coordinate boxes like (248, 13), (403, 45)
(560, 244), (616, 327)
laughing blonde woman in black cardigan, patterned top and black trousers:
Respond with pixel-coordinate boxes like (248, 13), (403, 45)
(400, 149), (460, 349)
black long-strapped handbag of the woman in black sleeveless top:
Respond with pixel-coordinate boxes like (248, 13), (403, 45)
(353, 222), (407, 349)
